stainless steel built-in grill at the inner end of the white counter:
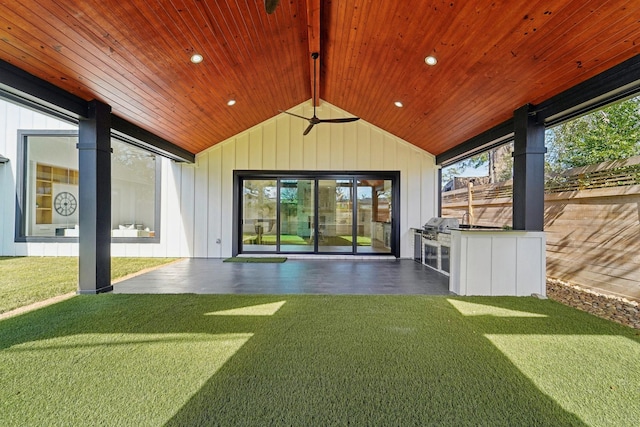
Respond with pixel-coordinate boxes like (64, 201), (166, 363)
(422, 217), (459, 275)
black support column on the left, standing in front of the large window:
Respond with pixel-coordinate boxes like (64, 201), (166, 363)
(78, 100), (113, 294)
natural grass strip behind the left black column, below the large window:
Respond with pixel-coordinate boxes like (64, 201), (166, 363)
(0, 257), (175, 314)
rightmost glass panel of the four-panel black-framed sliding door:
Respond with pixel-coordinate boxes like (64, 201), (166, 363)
(356, 179), (392, 253)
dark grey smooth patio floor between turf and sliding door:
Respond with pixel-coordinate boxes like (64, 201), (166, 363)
(113, 258), (449, 295)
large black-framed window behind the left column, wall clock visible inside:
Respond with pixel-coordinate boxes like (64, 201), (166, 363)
(16, 131), (160, 241)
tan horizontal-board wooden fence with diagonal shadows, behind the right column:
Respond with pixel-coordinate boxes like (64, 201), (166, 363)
(442, 156), (640, 300)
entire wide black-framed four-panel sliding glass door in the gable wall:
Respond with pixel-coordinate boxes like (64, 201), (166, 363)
(234, 172), (399, 254)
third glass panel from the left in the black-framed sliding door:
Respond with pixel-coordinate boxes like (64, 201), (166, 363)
(316, 179), (354, 253)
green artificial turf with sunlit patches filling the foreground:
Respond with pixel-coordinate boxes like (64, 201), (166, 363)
(0, 294), (640, 426)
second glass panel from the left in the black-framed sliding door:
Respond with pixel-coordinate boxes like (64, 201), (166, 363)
(280, 179), (315, 252)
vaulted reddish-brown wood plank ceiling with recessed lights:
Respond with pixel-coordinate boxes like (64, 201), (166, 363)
(0, 0), (640, 154)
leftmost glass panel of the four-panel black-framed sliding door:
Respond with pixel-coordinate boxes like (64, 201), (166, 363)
(242, 179), (278, 252)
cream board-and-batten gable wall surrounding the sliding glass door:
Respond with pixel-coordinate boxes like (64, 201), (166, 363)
(170, 102), (438, 258)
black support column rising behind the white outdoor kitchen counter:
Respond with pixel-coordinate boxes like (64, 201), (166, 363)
(513, 104), (546, 231)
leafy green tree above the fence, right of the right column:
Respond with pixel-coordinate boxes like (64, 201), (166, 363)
(546, 97), (640, 172)
